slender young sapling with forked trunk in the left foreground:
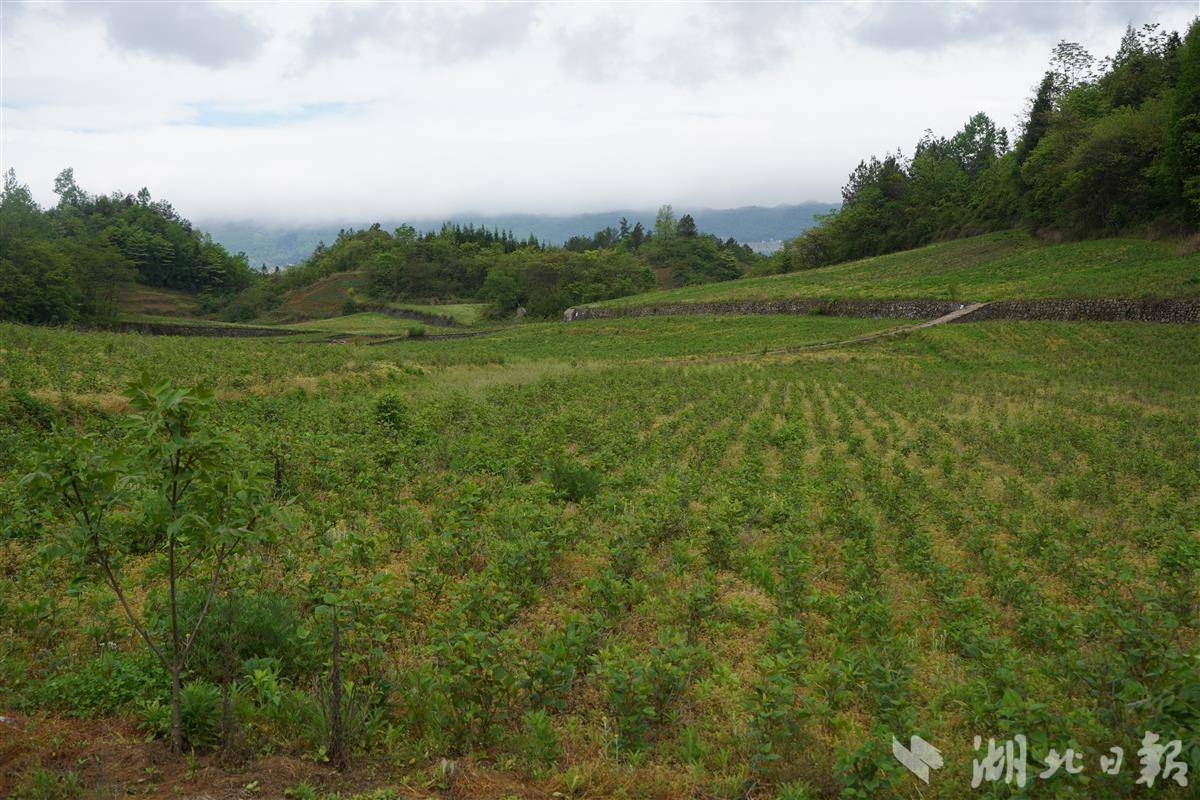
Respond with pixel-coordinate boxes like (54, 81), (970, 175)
(22, 375), (272, 752)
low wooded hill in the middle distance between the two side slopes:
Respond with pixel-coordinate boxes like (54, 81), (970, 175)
(228, 206), (766, 319)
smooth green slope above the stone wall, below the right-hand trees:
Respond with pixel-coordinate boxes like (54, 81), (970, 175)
(596, 231), (1200, 306)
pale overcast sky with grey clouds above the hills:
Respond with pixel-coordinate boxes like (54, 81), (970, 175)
(0, 0), (1200, 222)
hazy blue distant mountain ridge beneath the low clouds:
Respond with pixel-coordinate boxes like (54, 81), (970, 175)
(197, 203), (836, 266)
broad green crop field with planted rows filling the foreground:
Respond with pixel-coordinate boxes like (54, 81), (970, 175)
(0, 314), (1200, 798)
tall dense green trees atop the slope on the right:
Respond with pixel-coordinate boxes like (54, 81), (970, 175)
(772, 19), (1200, 271)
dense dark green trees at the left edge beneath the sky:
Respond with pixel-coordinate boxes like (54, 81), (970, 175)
(0, 168), (254, 323)
